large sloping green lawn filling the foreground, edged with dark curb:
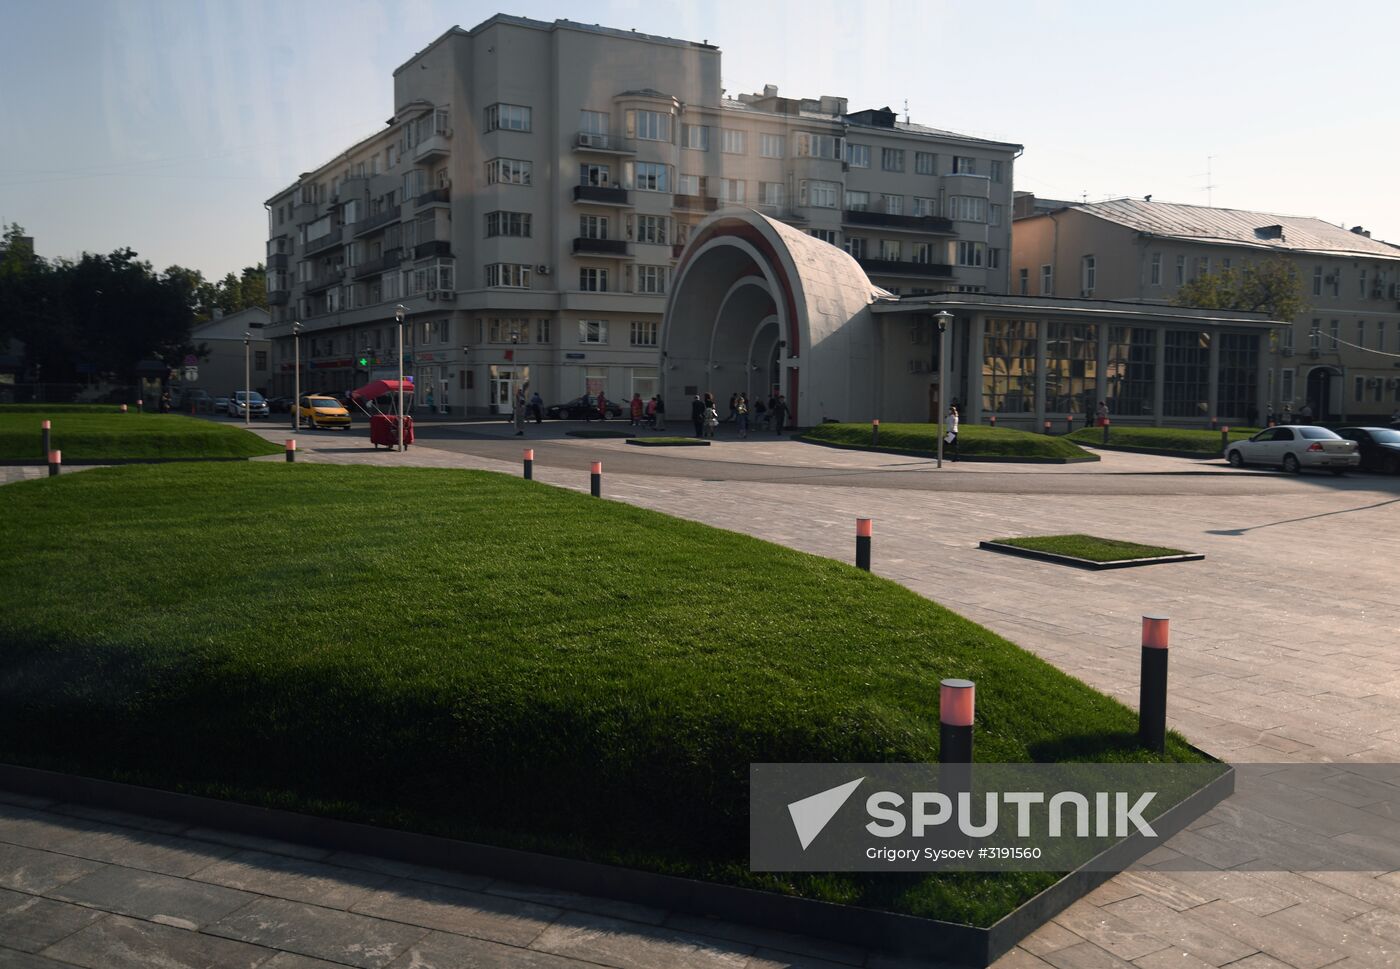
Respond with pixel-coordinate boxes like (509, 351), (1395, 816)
(0, 462), (1198, 924)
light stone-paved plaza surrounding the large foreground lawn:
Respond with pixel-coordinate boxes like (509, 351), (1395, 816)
(0, 423), (1400, 969)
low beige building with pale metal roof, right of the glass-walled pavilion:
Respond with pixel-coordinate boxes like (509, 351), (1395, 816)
(1011, 199), (1400, 420)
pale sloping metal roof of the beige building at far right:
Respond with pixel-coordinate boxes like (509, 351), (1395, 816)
(1070, 199), (1400, 259)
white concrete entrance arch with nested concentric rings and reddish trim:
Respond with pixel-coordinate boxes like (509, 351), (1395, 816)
(661, 209), (889, 424)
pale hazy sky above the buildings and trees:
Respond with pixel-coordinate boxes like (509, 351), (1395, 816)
(0, 0), (1400, 276)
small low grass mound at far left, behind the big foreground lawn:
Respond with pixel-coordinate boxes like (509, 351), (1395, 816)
(0, 405), (281, 461)
